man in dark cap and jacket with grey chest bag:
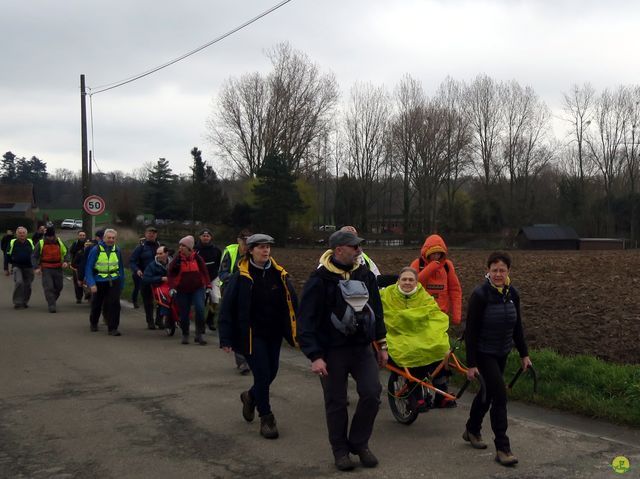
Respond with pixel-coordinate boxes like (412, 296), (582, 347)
(297, 231), (388, 471)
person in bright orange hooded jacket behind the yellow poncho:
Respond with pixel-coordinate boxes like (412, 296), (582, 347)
(411, 235), (462, 324)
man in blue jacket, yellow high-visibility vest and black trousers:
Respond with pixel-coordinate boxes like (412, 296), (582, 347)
(84, 228), (125, 336)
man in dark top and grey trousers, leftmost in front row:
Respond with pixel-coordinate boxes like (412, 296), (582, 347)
(7, 226), (33, 309)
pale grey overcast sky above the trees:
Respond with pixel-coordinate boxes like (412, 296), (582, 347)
(0, 0), (640, 173)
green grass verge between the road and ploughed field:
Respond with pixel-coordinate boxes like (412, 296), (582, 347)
(450, 347), (640, 427)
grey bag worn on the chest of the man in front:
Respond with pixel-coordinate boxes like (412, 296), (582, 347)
(331, 279), (376, 341)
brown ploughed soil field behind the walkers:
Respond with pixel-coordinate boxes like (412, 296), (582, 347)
(273, 248), (640, 364)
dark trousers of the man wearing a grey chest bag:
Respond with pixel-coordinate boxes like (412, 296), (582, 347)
(320, 344), (382, 457)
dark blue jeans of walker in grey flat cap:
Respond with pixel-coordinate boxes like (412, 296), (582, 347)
(245, 336), (282, 417)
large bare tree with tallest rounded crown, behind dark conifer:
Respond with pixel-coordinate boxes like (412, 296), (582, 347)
(208, 43), (338, 176)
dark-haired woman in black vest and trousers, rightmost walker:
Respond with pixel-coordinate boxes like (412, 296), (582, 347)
(462, 252), (531, 466)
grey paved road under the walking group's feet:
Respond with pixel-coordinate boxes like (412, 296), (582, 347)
(0, 277), (640, 479)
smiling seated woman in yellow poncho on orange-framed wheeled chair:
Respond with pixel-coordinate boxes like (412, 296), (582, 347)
(380, 268), (456, 410)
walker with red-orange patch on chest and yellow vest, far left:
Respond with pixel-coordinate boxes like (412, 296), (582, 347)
(33, 228), (67, 313)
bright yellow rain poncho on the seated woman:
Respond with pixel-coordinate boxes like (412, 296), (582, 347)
(380, 284), (449, 367)
